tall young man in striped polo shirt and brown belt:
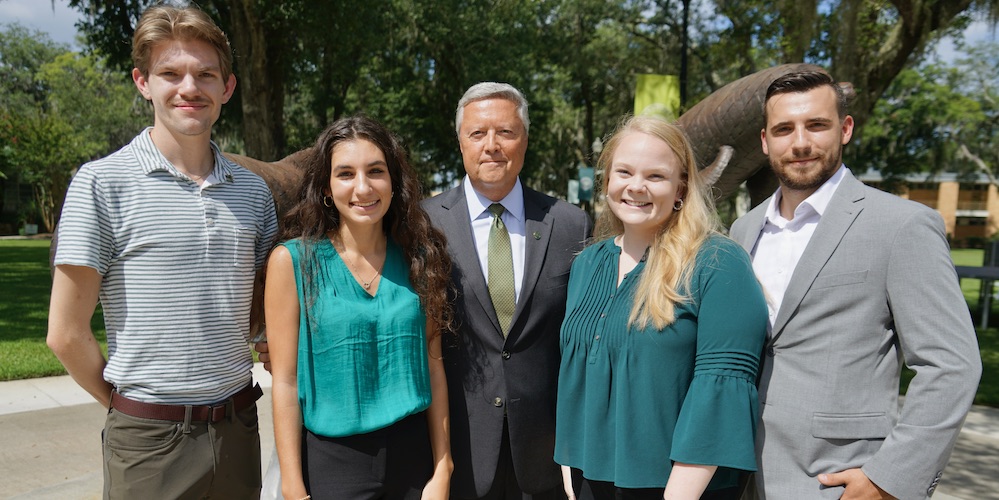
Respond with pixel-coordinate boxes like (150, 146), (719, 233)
(48, 6), (277, 498)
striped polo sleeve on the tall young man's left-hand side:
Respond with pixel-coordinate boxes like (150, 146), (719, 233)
(53, 165), (115, 276)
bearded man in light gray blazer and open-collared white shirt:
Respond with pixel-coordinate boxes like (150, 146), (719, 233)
(731, 68), (981, 500)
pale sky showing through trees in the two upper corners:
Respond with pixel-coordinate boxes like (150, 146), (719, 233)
(0, 0), (999, 61)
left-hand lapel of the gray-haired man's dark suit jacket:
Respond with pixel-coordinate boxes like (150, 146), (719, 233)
(441, 186), (504, 337)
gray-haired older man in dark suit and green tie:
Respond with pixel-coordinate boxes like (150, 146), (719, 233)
(423, 82), (590, 499)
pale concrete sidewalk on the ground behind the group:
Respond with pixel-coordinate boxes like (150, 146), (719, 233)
(0, 363), (999, 500)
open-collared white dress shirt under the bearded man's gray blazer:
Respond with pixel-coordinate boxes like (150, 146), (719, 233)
(752, 165), (846, 330)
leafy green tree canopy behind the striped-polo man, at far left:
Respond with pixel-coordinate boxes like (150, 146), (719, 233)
(0, 25), (151, 231)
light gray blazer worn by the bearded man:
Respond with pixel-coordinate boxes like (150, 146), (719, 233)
(731, 171), (982, 500)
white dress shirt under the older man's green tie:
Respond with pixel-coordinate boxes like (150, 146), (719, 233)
(462, 175), (527, 301)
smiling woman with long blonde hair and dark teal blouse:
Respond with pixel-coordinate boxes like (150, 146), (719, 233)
(555, 116), (767, 499)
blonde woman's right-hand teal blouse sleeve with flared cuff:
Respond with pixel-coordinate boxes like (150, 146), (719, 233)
(670, 238), (767, 471)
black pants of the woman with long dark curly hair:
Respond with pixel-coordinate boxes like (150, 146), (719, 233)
(302, 413), (434, 500)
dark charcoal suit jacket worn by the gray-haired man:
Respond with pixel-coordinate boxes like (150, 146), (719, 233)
(423, 186), (591, 497)
